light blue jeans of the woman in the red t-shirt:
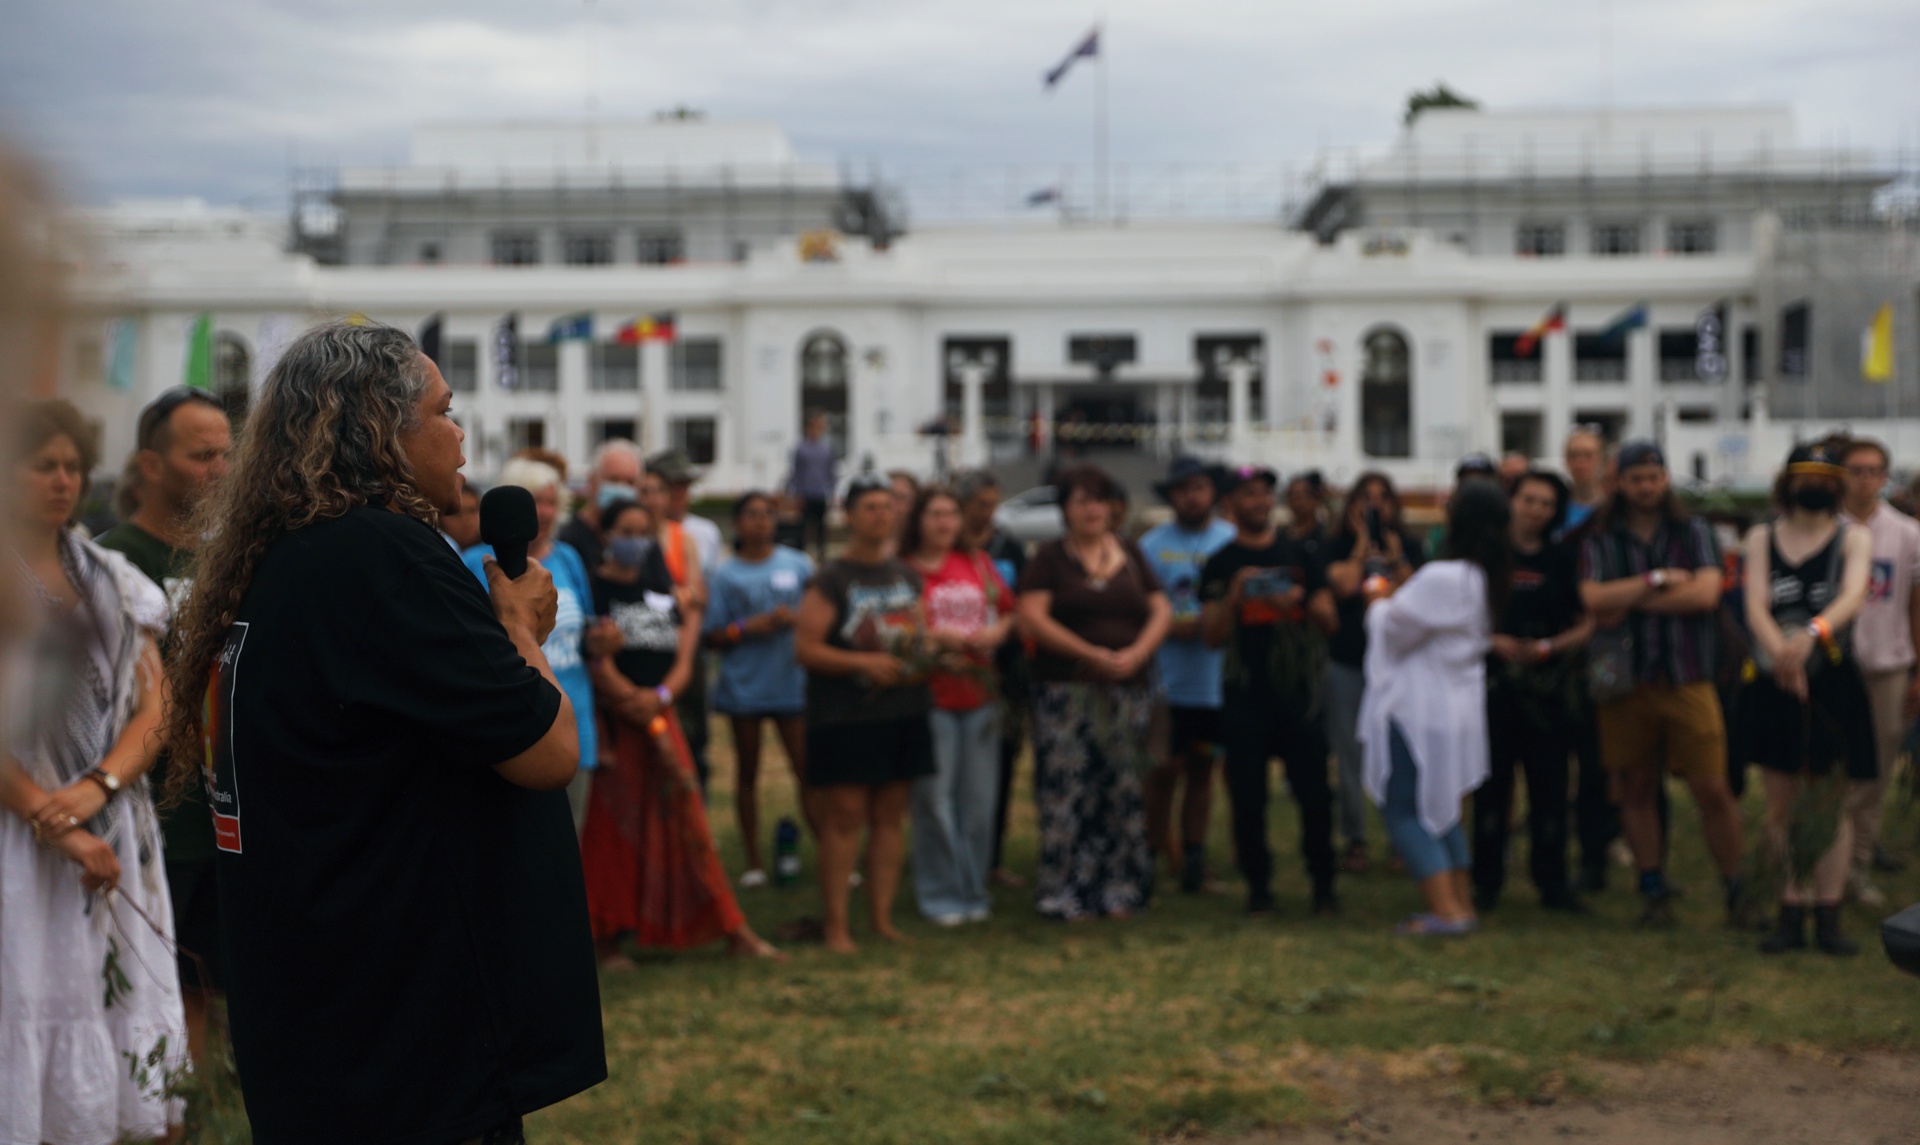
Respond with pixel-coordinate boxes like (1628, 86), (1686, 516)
(914, 703), (1000, 918)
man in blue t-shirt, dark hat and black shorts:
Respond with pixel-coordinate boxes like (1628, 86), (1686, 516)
(1140, 457), (1235, 891)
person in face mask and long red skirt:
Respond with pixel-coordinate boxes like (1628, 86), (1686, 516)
(580, 501), (780, 968)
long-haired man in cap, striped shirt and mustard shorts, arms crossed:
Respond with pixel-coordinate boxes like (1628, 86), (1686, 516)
(1580, 442), (1743, 926)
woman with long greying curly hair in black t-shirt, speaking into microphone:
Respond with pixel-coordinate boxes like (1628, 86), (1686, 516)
(167, 323), (607, 1145)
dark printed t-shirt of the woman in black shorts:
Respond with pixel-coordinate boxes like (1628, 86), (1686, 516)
(806, 557), (933, 728)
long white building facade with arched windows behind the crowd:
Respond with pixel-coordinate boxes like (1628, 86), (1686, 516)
(65, 113), (1920, 492)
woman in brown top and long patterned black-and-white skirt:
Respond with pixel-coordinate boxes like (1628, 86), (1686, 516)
(1020, 465), (1171, 920)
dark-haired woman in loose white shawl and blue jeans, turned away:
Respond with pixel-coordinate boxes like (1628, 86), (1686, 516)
(1359, 480), (1513, 936)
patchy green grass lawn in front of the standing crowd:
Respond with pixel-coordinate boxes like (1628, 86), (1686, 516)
(205, 726), (1920, 1145)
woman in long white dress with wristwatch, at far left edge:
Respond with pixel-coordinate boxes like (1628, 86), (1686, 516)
(0, 402), (186, 1145)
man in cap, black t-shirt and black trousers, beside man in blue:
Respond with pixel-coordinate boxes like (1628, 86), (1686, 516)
(1200, 467), (1336, 914)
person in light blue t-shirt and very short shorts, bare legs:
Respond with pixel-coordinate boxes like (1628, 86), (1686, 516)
(703, 492), (814, 889)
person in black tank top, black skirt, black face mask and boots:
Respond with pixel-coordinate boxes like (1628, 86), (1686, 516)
(1734, 446), (1876, 955)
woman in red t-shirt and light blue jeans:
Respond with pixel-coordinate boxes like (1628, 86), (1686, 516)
(900, 486), (1014, 926)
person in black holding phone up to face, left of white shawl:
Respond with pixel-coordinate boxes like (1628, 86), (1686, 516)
(1323, 473), (1427, 872)
